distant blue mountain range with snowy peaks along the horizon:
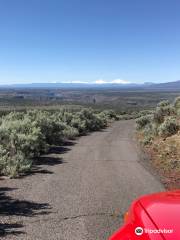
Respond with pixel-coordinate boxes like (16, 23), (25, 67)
(0, 80), (180, 91)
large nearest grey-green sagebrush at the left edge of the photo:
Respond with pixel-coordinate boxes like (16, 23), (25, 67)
(0, 120), (45, 176)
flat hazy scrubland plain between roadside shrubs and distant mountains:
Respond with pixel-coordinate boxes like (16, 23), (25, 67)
(0, 87), (180, 115)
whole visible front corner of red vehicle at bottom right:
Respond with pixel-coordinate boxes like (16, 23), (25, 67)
(109, 190), (180, 240)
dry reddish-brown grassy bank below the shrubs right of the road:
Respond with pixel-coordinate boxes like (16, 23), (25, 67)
(138, 132), (180, 189)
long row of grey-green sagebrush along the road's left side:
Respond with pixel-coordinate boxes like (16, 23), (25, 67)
(0, 108), (117, 177)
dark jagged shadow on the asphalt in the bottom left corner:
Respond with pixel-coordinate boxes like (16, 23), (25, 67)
(0, 187), (51, 239)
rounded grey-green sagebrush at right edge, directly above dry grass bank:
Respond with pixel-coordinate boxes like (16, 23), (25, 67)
(158, 117), (179, 137)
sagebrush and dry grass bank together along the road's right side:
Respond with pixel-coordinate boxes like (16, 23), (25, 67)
(136, 97), (180, 188)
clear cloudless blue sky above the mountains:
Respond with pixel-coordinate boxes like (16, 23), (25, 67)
(0, 0), (180, 84)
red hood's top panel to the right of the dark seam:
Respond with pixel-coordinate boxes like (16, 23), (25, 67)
(139, 190), (180, 240)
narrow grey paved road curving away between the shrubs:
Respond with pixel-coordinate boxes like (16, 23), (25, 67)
(0, 120), (163, 240)
